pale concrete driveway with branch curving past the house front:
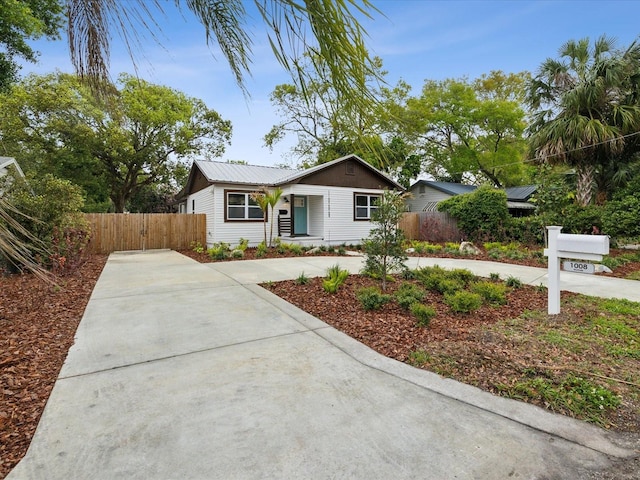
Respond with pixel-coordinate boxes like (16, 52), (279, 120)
(8, 251), (640, 480)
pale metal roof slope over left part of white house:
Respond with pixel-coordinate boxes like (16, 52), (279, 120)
(196, 160), (299, 185)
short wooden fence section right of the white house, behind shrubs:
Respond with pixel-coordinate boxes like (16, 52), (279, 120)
(399, 212), (464, 242)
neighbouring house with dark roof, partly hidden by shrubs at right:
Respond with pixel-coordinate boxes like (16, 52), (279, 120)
(406, 180), (537, 217)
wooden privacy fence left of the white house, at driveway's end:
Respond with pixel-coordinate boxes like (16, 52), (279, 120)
(86, 213), (207, 253)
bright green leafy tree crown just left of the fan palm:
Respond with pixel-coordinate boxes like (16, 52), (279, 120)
(386, 71), (528, 187)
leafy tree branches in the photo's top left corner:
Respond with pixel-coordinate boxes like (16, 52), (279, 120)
(0, 0), (64, 91)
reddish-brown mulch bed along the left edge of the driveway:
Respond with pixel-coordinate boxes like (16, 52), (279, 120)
(0, 255), (107, 478)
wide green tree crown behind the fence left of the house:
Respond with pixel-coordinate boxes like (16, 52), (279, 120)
(0, 73), (231, 212)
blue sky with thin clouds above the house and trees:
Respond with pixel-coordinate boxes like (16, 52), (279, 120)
(21, 0), (640, 165)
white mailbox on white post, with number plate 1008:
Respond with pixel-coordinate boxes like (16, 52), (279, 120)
(544, 225), (609, 315)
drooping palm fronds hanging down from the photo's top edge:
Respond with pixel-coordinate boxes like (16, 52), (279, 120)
(66, 0), (379, 106)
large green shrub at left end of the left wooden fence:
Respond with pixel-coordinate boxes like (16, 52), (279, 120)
(5, 175), (90, 271)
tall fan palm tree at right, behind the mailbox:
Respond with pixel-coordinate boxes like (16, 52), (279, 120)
(527, 36), (640, 206)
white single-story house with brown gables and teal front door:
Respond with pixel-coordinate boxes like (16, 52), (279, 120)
(178, 155), (403, 246)
